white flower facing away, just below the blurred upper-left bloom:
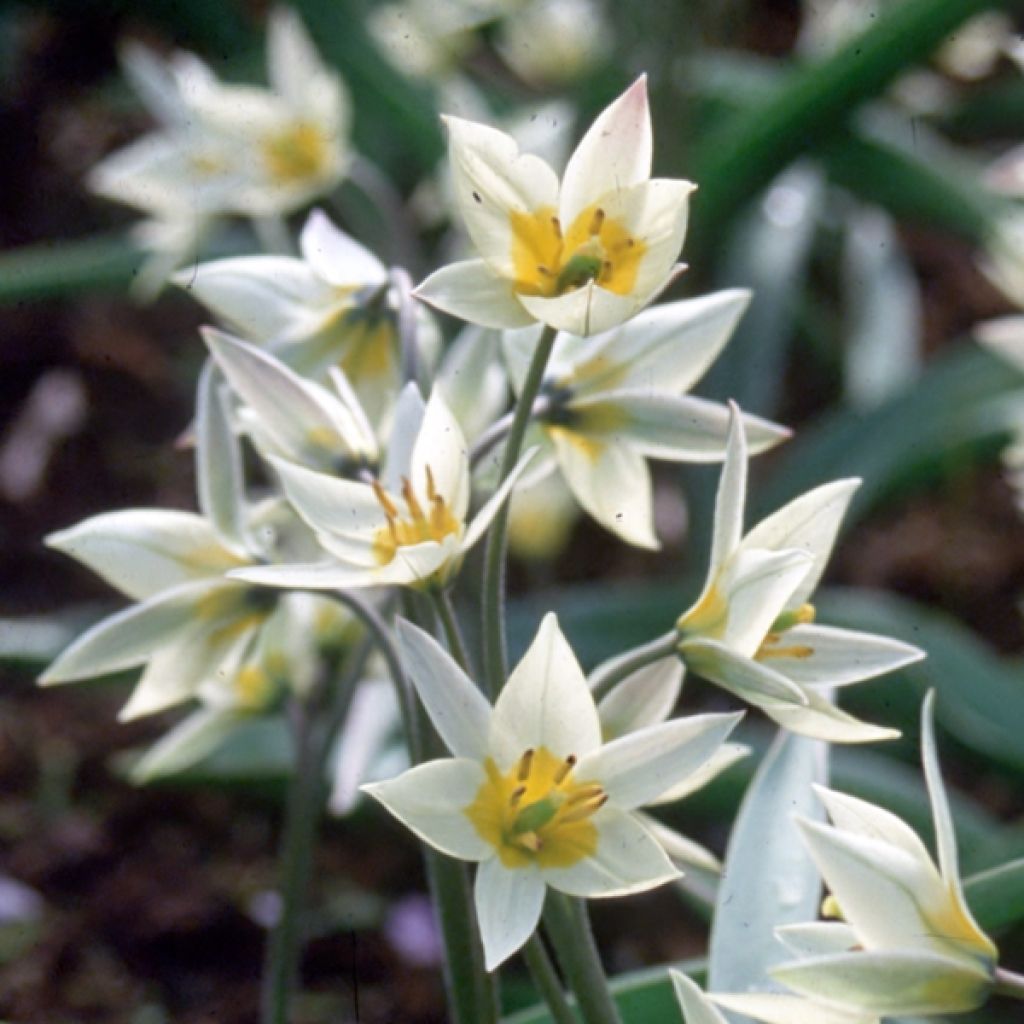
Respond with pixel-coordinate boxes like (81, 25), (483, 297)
(180, 210), (437, 424)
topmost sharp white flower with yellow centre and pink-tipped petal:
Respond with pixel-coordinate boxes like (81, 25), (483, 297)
(416, 78), (694, 335)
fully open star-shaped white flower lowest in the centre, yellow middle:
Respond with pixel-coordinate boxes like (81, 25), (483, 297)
(366, 614), (739, 970)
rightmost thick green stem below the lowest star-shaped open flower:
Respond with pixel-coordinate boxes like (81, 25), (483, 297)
(544, 889), (623, 1024)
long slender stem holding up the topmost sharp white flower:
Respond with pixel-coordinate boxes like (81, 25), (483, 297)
(483, 326), (558, 697)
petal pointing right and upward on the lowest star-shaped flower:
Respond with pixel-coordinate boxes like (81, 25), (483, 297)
(573, 714), (742, 811)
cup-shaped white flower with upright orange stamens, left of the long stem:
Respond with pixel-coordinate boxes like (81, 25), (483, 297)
(231, 384), (530, 589)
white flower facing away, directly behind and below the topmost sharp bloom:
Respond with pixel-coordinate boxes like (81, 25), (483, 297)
(505, 289), (788, 548)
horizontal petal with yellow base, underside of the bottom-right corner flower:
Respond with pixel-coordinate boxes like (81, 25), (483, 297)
(771, 951), (992, 1017)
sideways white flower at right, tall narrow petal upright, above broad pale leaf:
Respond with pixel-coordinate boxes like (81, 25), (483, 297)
(676, 408), (924, 742)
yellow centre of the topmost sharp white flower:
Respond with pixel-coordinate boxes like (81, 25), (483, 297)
(509, 204), (647, 298)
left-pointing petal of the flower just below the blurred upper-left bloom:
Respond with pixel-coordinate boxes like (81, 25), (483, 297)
(173, 256), (323, 342)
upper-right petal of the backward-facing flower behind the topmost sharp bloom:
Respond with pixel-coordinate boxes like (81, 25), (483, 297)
(575, 288), (751, 394)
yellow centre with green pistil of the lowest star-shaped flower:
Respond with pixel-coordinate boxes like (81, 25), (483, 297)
(465, 746), (608, 867)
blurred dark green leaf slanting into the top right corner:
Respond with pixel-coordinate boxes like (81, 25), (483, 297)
(692, 0), (1009, 248)
